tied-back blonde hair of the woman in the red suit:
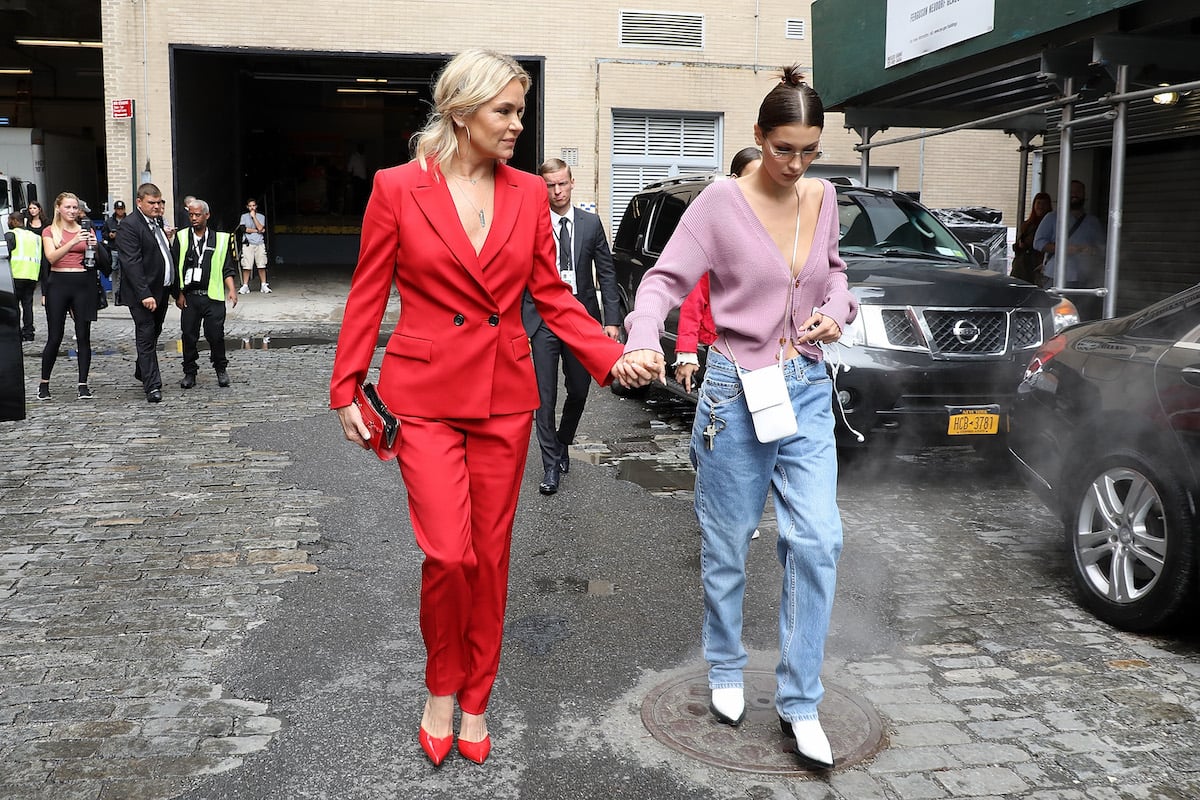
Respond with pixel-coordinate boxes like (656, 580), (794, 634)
(412, 48), (533, 176)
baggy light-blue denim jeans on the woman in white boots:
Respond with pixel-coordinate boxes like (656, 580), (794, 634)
(691, 348), (841, 721)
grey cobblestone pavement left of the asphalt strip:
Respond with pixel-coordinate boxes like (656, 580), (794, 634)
(0, 293), (348, 800)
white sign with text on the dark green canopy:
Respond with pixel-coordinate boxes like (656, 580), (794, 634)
(883, 0), (996, 68)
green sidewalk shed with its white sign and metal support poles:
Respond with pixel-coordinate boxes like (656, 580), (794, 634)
(811, 0), (1200, 317)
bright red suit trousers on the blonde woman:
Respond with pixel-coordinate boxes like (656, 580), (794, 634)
(398, 411), (533, 714)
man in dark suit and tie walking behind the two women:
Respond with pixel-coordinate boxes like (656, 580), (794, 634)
(521, 158), (620, 494)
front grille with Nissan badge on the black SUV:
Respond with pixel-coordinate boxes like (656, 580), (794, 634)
(881, 307), (1042, 357)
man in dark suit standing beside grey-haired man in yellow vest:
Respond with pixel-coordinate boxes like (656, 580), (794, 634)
(116, 184), (175, 403)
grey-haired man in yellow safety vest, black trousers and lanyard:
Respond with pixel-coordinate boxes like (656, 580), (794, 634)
(170, 198), (238, 389)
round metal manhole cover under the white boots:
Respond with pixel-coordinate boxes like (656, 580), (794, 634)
(642, 670), (883, 777)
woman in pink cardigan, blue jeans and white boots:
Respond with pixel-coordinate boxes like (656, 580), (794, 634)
(624, 66), (857, 769)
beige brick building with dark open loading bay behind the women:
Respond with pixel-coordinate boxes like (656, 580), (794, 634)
(102, 0), (1018, 260)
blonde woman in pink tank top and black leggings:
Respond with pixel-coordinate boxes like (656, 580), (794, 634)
(37, 192), (97, 401)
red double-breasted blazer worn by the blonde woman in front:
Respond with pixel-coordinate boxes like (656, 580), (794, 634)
(329, 162), (623, 419)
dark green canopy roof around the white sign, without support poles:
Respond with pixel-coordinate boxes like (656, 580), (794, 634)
(812, 0), (1200, 131)
